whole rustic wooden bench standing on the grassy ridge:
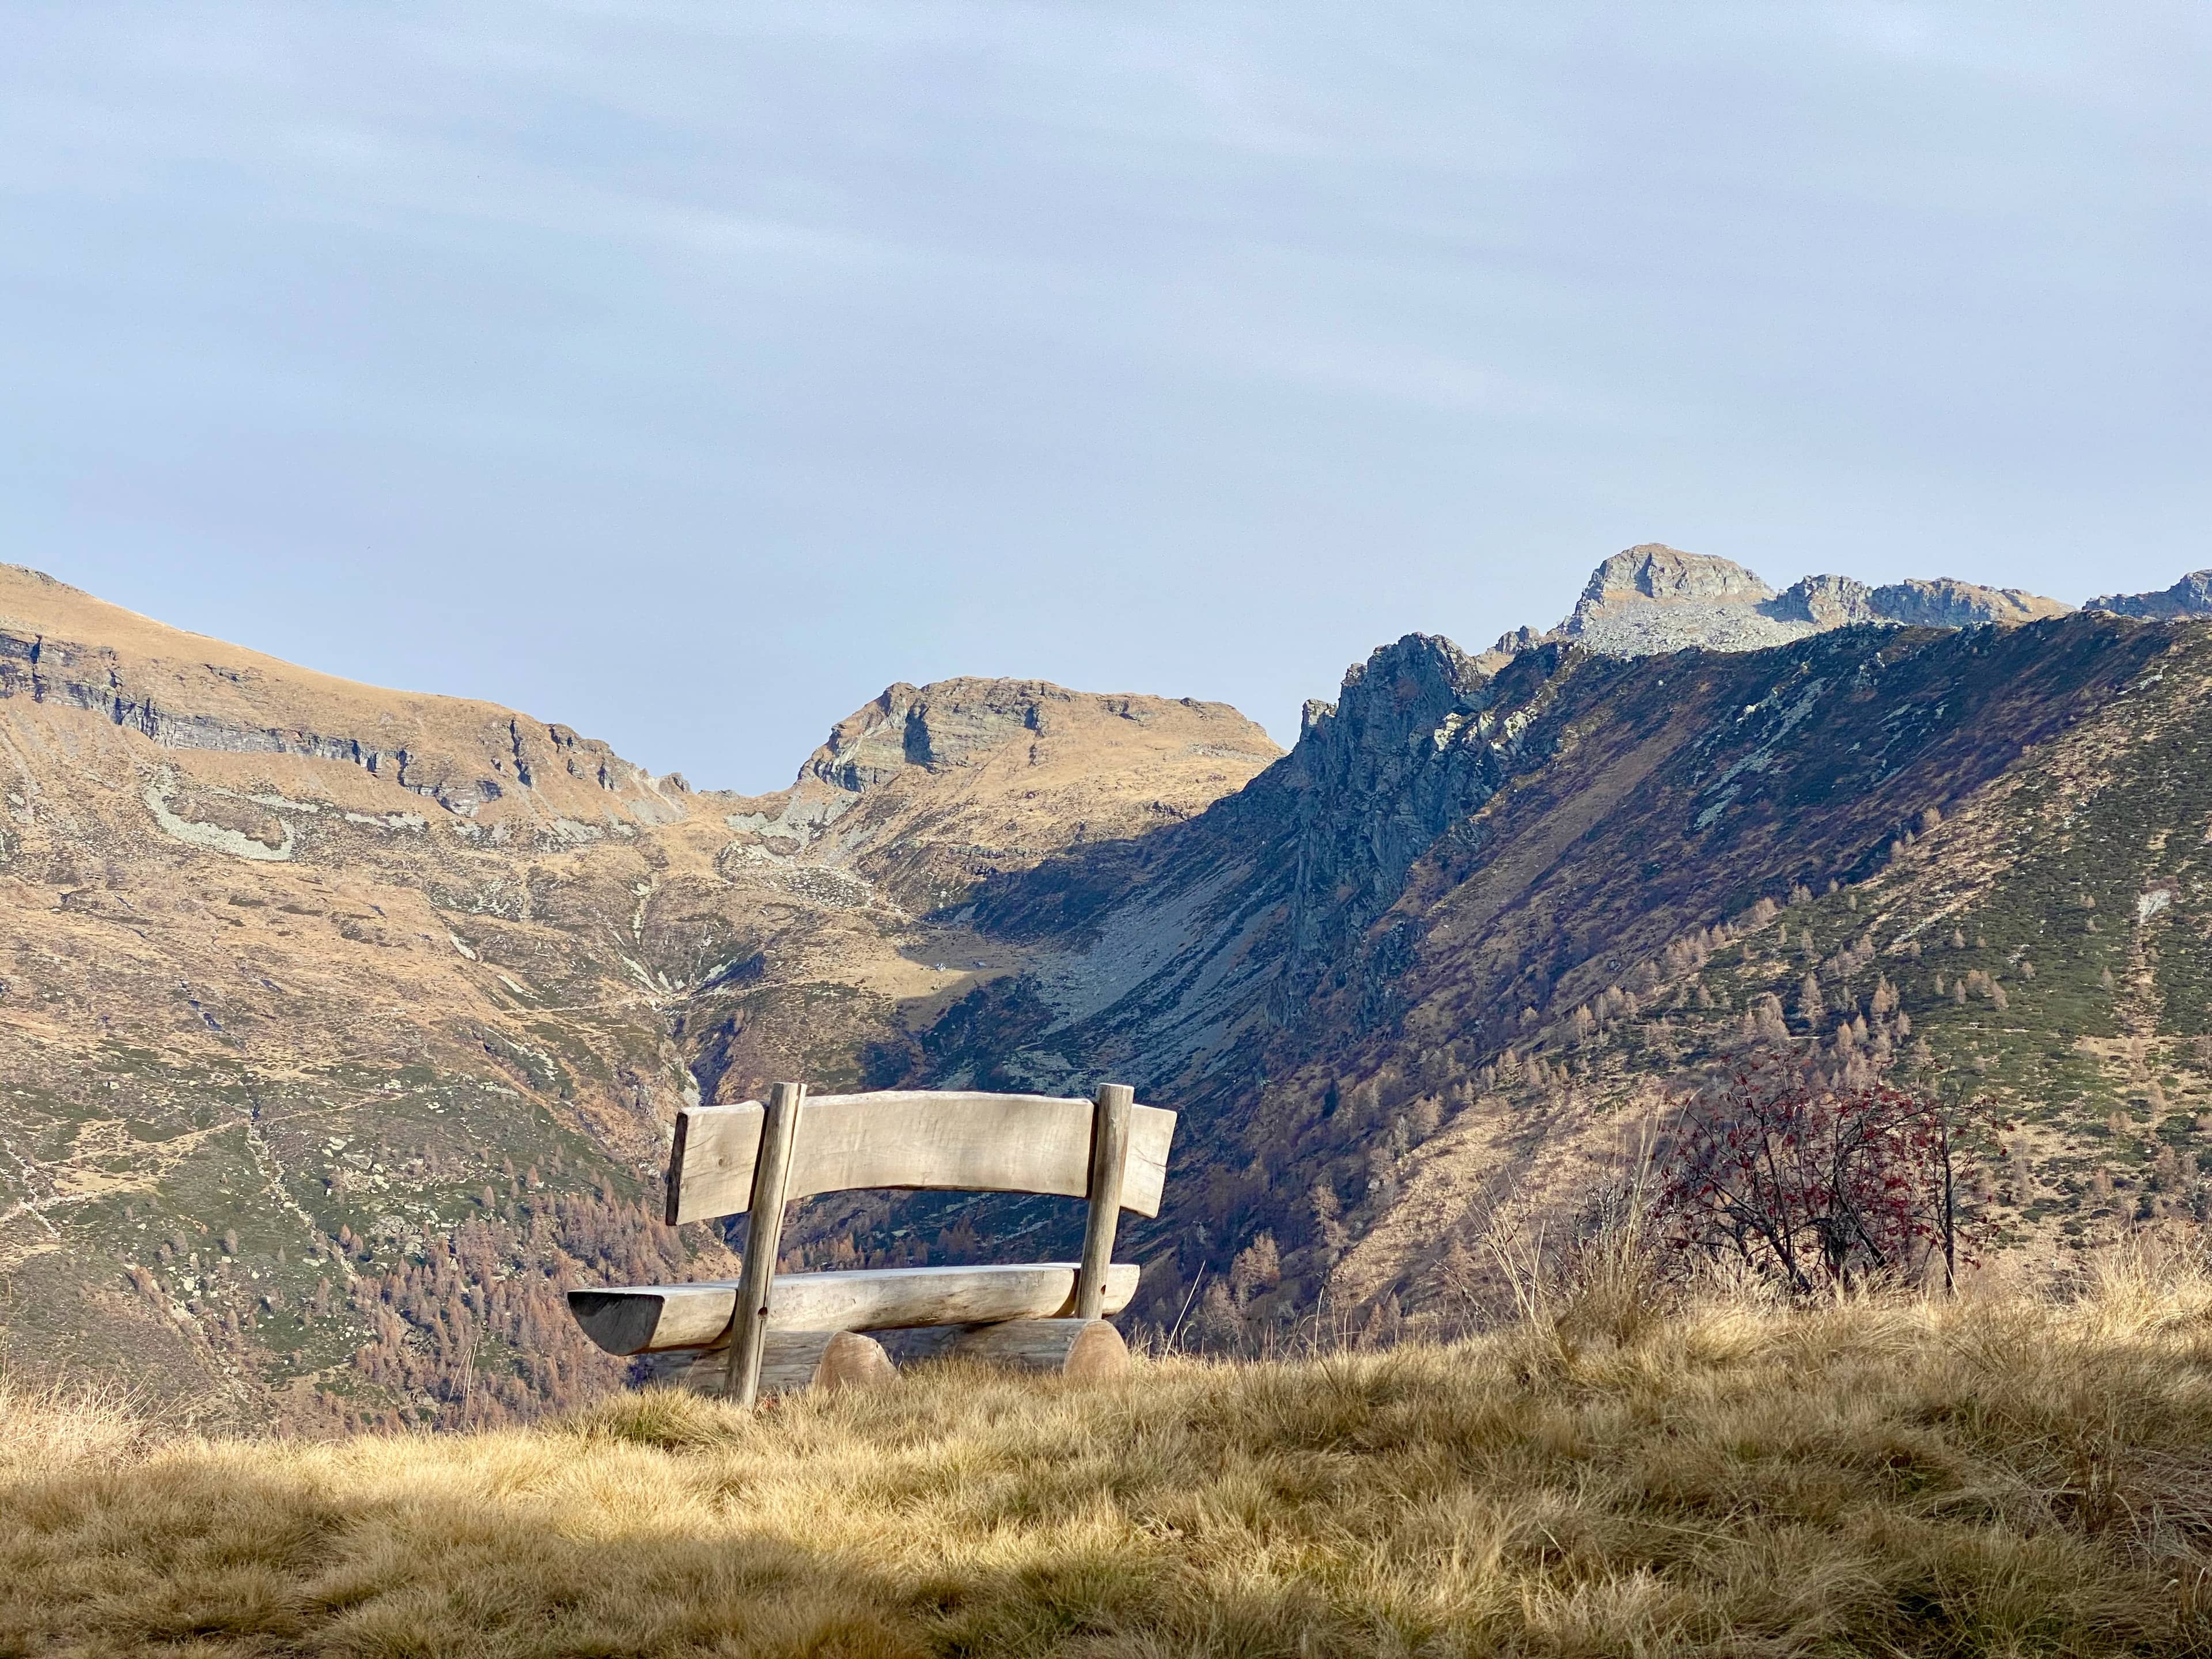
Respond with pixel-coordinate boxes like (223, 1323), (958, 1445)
(569, 1084), (1175, 1404)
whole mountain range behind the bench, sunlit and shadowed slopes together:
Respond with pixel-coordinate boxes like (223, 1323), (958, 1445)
(0, 546), (2212, 1431)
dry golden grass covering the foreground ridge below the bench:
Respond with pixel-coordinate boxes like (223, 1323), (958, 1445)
(13, 1261), (2212, 1659)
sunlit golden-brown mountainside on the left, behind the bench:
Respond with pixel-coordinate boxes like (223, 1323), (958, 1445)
(0, 569), (1274, 1420)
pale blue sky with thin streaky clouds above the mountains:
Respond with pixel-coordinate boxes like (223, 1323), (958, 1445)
(0, 0), (2212, 790)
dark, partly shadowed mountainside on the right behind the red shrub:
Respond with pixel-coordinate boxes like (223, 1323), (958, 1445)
(942, 615), (2212, 1323)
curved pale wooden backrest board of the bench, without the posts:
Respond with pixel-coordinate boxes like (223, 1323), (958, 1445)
(668, 1088), (1175, 1224)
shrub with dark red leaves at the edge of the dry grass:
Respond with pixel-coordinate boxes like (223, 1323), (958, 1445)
(1652, 1062), (1991, 1296)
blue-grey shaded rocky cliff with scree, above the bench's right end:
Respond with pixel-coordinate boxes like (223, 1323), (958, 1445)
(942, 635), (1559, 1093)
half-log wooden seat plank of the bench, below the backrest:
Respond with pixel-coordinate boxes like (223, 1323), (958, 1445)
(569, 1261), (1139, 1356)
